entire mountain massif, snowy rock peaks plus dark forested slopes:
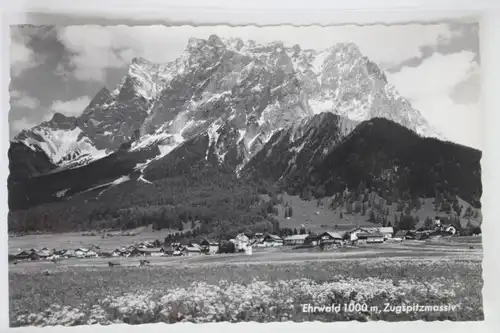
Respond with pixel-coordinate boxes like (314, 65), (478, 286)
(8, 35), (481, 233)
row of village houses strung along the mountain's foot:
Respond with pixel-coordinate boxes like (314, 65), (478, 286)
(9, 218), (470, 266)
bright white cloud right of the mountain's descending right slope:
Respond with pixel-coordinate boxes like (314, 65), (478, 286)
(388, 51), (482, 149)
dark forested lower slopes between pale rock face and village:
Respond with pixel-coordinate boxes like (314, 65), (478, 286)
(9, 113), (482, 235)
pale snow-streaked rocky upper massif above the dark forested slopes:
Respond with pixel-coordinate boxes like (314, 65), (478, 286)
(10, 35), (439, 169)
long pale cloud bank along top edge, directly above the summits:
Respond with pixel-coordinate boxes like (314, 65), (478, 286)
(54, 24), (451, 82)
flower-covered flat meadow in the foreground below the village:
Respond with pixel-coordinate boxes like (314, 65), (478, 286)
(9, 237), (483, 326)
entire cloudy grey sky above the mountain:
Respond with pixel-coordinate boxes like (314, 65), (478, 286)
(9, 23), (482, 149)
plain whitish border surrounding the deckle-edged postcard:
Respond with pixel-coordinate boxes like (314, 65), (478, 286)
(0, 0), (500, 333)
